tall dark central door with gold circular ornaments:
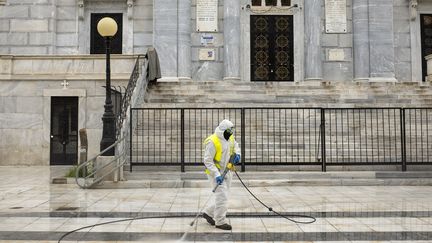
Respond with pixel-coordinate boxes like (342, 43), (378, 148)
(250, 15), (294, 81)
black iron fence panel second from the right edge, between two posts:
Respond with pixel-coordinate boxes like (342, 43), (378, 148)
(325, 108), (402, 165)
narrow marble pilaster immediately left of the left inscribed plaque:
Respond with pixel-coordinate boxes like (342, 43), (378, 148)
(177, 0), (192, 79)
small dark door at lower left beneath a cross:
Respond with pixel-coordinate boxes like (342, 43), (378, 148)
(50, 97), (78, 165)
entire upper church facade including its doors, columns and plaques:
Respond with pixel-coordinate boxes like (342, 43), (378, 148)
(0, 0), (432, 81)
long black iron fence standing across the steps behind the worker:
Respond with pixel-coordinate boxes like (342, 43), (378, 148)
(130, 108), (432, 171)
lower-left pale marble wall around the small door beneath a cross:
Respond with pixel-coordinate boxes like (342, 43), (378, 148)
(0, 56), (135, 165)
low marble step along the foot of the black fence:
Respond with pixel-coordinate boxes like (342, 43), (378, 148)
(88, 171), (432, 188)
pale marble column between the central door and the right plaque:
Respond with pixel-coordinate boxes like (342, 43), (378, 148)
(304, 0), (323, 80)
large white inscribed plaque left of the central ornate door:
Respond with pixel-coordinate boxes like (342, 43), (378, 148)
(196, 0), (218, 32)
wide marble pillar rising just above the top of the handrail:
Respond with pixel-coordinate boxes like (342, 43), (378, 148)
(153, 0), (177, 78)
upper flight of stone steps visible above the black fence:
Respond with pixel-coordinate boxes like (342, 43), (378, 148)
(143, 81), (432, 107)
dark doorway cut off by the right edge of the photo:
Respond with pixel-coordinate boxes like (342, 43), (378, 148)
(420, 14), (432, 81)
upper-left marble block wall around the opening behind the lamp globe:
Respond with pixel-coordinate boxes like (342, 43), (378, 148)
(0, 0), (153, 55)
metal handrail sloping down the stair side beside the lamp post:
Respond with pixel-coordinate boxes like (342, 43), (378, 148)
(75, 55), (148, 189)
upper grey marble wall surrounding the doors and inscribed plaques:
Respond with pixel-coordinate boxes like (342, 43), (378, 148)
(0, 0), (420, 81)
